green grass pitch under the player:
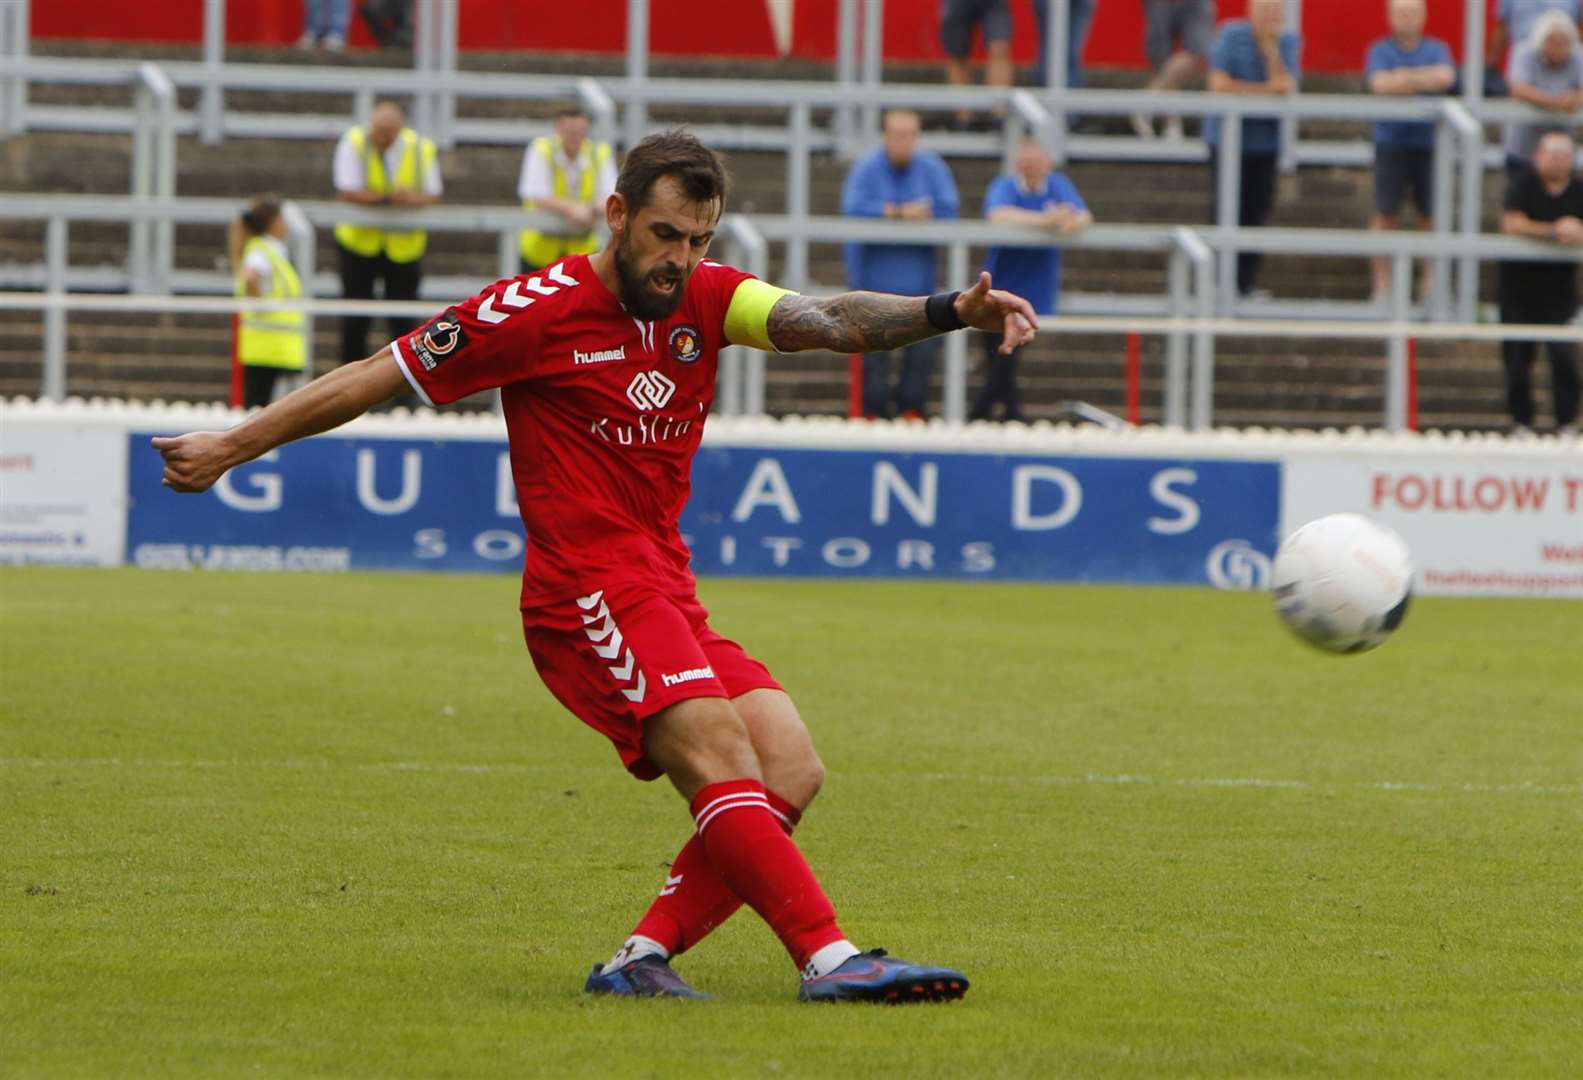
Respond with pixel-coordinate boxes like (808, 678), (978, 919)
(0, 570), (1583, 1077)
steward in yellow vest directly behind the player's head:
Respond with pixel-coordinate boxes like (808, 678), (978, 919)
(516, 106), (616, 274)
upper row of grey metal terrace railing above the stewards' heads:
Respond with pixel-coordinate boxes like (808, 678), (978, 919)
(0, 49), (1583, 321)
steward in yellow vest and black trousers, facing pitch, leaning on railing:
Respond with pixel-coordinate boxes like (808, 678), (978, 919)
(334, 101), (443, 364)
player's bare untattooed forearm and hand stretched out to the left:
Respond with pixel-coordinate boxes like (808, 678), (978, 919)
(154, 345), (407, 492)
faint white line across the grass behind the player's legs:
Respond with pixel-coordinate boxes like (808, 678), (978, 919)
(0, 757), (1583, 795)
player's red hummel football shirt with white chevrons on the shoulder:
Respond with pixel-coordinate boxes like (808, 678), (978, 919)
(391, 255), (750, 607)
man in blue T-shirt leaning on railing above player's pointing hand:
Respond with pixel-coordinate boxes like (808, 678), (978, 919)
(967, 139), (1094, 423)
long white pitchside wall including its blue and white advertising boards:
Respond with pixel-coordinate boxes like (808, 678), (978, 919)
(0, 401), (1583, 599)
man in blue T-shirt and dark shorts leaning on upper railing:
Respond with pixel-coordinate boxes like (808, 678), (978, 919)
(1365, 0), (1456, 304)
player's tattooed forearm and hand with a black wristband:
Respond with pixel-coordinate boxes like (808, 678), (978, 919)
(766, 274), (1038, 353)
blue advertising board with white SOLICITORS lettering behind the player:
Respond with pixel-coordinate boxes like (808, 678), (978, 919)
(127, 434), (1281, 588)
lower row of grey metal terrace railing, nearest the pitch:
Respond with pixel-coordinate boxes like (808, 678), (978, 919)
(0, 196), (1583, 431)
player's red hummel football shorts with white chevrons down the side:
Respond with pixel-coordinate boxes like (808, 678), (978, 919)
(522, 584), (782, 781)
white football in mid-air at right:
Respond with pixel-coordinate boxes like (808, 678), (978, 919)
(1270, 513), (1412, 652)
